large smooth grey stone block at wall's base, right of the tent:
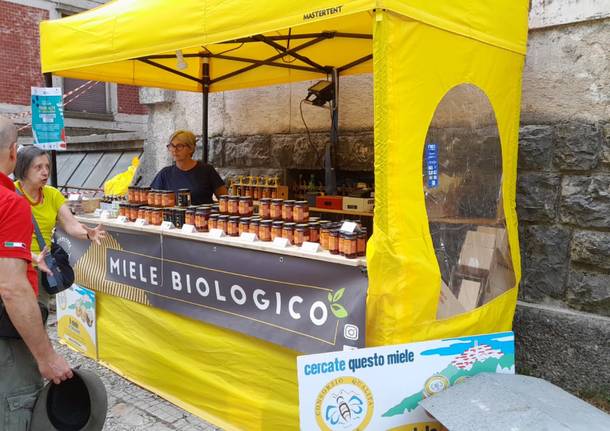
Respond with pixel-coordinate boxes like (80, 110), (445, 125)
(514, 303), (610, 396)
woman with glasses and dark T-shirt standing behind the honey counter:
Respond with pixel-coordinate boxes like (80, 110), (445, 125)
(150, 130), (227, 205)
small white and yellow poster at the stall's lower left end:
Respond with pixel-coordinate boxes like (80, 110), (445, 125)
(55, 284), (97, 359)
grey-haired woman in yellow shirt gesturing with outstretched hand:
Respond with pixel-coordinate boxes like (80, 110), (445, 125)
(15, 146), (106, 302)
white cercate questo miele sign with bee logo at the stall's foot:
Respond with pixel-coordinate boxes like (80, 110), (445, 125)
(297, 332), (515, 431)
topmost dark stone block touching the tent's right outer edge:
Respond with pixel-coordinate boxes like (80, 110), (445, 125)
(519, 126), (553, 170)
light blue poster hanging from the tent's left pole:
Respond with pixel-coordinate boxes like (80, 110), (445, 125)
(32, 87), (67, 151)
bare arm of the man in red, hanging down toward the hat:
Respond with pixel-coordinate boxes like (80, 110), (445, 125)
(0, 257), (73, 384)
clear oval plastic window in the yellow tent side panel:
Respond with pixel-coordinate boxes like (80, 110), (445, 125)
(423, 84), (515, 319)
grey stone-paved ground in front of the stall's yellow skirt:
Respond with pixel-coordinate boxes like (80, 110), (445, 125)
(48, 315), (222, 431)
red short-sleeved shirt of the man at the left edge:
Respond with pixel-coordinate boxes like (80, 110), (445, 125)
(0, 172), (38, 296)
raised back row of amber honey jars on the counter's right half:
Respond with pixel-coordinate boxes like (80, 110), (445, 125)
(218, 195), (309, 223)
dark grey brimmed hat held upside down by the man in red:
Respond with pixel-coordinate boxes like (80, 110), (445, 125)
(30, 370), (108, 431)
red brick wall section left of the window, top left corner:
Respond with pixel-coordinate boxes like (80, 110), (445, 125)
(0, 0), (49, 105)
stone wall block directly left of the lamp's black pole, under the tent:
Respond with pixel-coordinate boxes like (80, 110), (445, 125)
(271, 133), (330, 169)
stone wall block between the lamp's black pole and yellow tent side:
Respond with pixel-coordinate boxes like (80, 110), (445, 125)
(337, 132), (375, 172)
